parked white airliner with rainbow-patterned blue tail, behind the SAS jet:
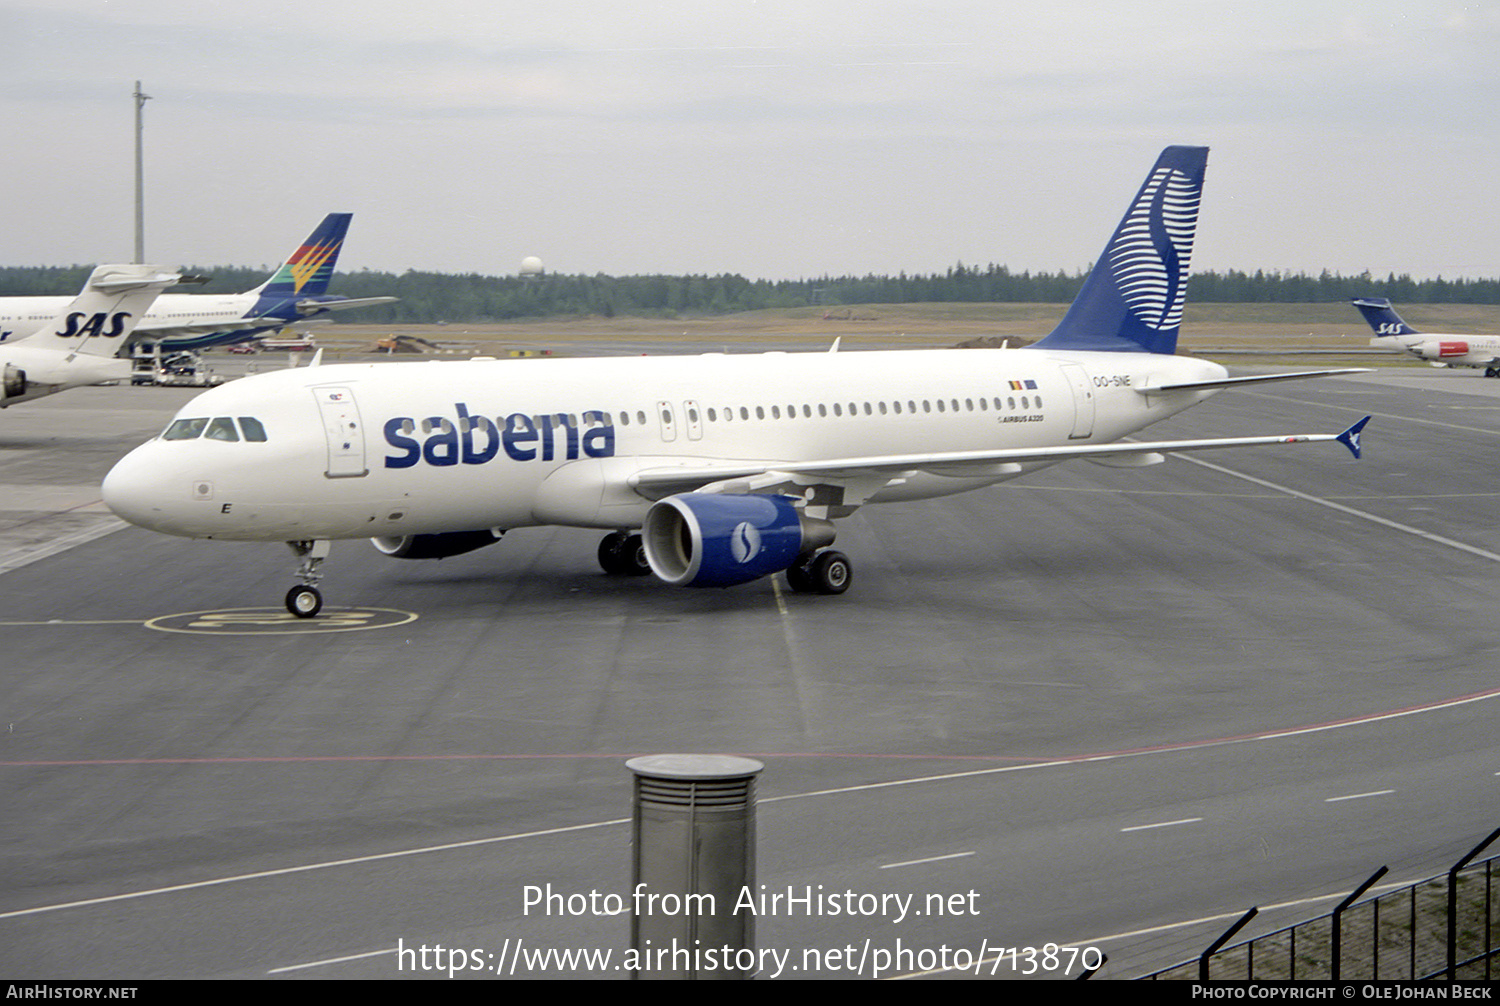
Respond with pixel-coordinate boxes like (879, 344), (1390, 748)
(0, 213), (396, 351)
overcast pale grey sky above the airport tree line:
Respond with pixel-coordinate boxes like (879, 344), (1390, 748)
(0, 0), (1500, 279)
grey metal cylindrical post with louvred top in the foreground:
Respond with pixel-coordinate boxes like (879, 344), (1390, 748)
(626, 754), (765, 981)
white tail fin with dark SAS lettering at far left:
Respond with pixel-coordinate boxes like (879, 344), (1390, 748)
(25, 265), (179, 357)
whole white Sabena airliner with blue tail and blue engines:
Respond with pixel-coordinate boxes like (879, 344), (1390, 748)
(104, 147), (1364, 616)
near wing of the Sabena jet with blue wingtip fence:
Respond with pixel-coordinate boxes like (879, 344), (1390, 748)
(629, 415), (1370, 505)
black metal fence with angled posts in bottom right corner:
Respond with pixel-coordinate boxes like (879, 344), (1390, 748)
(1142, 829), (1500, 981)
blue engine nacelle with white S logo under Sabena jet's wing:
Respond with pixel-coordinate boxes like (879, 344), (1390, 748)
(641, 493), (834, 586)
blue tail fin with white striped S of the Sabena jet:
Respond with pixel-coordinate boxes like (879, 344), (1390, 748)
(1035, 147), (1209, 354)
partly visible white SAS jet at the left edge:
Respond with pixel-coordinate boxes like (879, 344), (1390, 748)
(0, 265), (179, 409)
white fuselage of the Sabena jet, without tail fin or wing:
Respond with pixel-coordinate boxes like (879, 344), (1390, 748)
(105, 349), (1224, 541)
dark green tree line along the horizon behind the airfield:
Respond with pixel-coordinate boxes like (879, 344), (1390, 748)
(0, 262), (1500, 324)
